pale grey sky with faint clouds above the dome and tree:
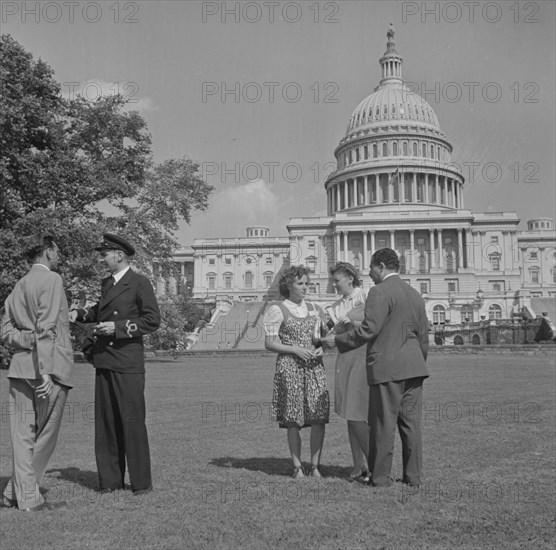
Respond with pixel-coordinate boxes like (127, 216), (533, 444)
(0, 0), (556, 246)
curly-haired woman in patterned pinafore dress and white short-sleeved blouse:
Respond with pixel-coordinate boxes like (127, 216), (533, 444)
(264, 266), (330, 478)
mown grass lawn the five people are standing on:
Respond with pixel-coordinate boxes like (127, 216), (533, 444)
(0, 354), (555, 550)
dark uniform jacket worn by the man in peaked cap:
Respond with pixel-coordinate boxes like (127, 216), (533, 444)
(78, 269), (160, 373)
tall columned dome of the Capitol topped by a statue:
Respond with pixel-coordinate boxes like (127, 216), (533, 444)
(324, 25), (464, 216)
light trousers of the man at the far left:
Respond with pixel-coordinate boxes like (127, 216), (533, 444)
(4, 378), (69, 510)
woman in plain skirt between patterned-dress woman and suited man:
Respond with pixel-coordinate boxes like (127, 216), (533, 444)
(325, 262), (369, 479)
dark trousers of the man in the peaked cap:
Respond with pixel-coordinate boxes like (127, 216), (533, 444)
(95, 368), (152, 491)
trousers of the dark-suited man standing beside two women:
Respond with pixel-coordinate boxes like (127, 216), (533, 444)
(369, 377), (423, 486)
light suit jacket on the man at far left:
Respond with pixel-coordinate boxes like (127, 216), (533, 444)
(1, 264), (73, 387)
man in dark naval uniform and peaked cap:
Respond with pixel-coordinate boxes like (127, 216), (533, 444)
(70, 233), (160, 494)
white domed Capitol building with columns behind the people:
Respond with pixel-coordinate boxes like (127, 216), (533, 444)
(163, 27), (556, 330)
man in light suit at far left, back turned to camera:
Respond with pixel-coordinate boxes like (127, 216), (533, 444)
(1, 234), (73, 512)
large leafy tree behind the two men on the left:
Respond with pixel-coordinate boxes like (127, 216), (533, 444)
(0, 35), (212, 354)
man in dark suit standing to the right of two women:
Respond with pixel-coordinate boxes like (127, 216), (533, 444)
(336, 248), (428, 486)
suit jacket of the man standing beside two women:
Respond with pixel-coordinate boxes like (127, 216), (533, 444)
(336, 275), (429, 386)
